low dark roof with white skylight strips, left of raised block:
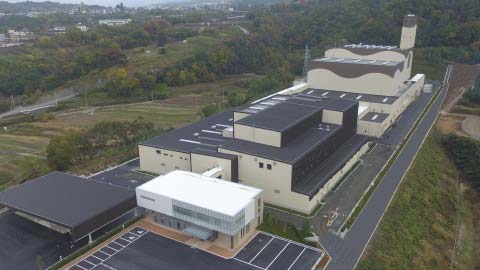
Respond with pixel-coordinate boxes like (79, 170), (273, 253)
(140, 110), (233, 153)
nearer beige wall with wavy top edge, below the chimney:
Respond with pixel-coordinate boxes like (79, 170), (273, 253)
(308, 68), (402, 96)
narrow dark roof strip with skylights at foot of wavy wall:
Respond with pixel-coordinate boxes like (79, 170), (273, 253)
(302, 88), (398, 104)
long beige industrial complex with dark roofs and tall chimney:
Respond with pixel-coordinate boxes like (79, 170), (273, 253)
(139, 15), (425, 213)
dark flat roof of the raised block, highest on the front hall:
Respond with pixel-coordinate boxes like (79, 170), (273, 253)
(237, 95), (356, 132)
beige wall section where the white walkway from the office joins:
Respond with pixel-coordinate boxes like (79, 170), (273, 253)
(191, 153), (232, 181)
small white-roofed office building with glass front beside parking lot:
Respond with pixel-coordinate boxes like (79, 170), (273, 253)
(136, 171), (263, 249)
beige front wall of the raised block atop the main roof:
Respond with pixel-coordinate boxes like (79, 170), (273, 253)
(234, 123), (281, 147)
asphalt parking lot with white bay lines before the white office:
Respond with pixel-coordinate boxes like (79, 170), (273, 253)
(70, 227), (324, 270)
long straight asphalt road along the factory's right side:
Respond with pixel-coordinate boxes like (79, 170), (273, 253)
(326, 66), (451, 270)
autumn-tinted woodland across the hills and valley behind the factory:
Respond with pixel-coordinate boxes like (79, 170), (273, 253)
(0, 0), (480, 103)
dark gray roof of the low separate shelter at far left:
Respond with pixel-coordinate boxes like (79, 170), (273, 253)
(0, 172), (136, 241)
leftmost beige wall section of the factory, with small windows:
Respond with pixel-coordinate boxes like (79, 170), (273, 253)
(138, 145), (191, 174)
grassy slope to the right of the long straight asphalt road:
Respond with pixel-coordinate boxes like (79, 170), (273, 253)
(358, 131), (478, 270)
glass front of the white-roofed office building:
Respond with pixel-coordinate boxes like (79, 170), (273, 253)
(172, 200), (245, 235)
